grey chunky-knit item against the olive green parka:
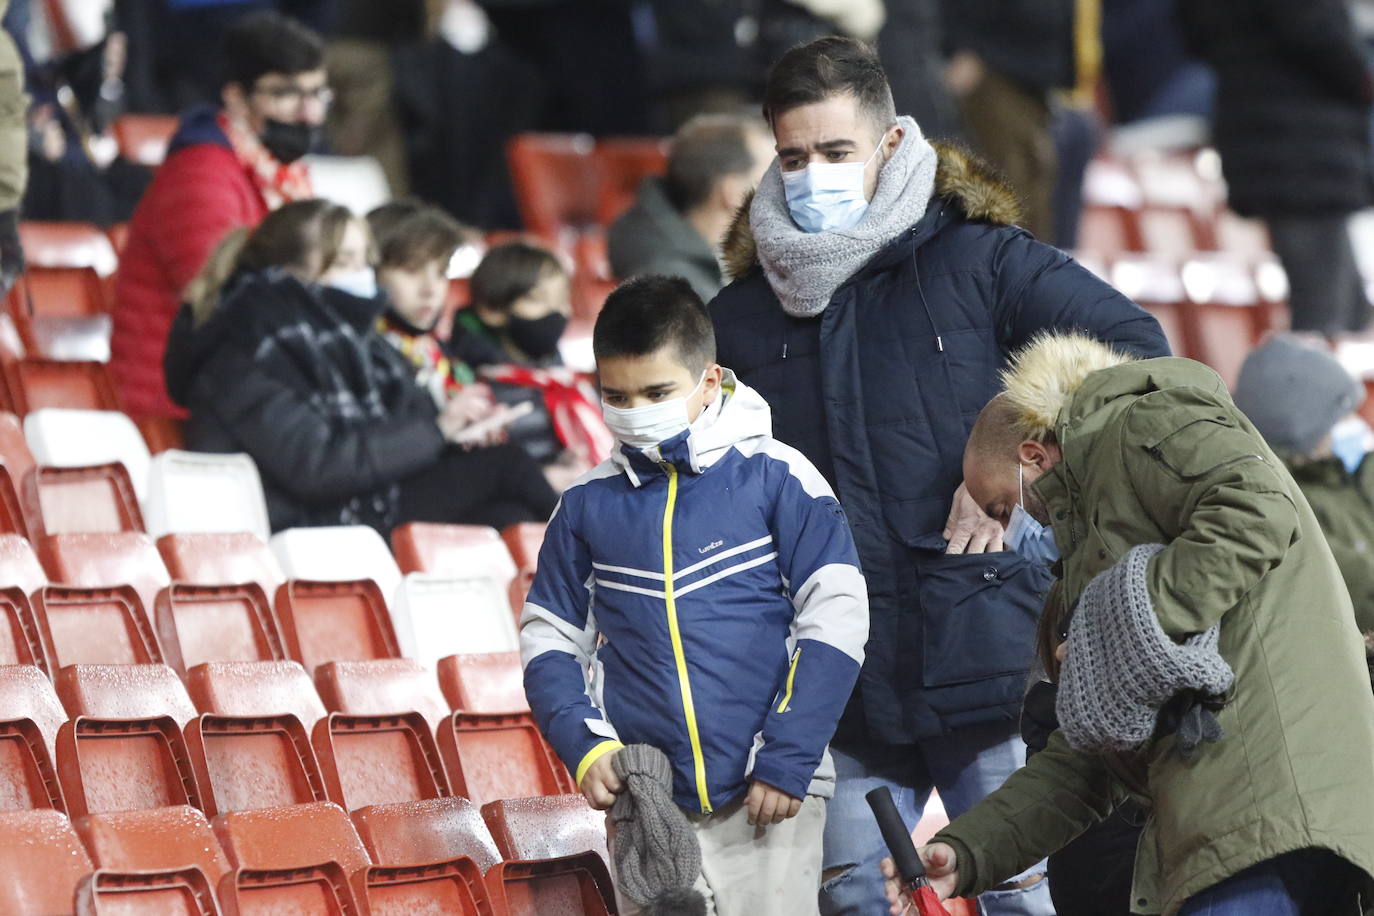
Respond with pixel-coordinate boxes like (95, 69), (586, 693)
(1055, 544), (1235, 757)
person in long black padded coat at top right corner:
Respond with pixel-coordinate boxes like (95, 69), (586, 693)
(1178, 0), (1374, 336)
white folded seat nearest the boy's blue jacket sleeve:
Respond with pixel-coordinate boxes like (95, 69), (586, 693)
(392, 573), (519, 666)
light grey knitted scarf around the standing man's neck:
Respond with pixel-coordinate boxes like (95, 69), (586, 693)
(749, 117), (940, 317)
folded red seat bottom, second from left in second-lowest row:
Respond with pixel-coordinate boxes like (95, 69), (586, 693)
(58, 715), (209, 818)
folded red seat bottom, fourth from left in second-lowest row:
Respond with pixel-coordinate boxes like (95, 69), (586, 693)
(312, 713), (449, 810)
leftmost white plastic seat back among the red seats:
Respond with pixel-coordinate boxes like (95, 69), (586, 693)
(23, 408), (150, 501)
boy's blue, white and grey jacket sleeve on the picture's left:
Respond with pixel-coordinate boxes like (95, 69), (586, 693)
(519, 489), (621, 786)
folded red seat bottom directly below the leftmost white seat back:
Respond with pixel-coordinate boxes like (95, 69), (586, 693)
(36, 463), (143, 534)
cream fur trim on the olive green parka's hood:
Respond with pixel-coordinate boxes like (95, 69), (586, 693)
(1002, 332), (1131, 442)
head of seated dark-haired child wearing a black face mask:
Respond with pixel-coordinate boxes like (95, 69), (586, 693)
(449, 242), (573, 368)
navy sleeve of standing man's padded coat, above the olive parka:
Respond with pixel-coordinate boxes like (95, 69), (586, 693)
(993, 229), (1171, 358)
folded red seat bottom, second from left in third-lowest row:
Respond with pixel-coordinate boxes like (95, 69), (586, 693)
(33, 585), (162, 670)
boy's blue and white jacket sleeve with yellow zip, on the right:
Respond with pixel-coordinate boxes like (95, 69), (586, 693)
(752, 446), (868, 798)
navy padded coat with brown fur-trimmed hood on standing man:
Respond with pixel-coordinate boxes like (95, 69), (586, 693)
(710, 146), (1169, 744)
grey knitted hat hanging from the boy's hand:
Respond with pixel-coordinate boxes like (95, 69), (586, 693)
(610, 744), (706, 916)
